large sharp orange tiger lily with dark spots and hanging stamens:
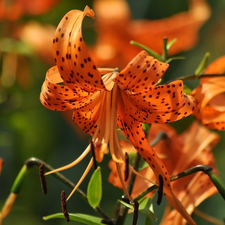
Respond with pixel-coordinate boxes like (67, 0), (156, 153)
(40, 6), (195, 224)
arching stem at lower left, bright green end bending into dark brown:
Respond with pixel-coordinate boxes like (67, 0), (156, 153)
(11, 157), (111, 221)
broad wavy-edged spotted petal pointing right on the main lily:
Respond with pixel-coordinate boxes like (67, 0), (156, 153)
(122, 80), (195, 123)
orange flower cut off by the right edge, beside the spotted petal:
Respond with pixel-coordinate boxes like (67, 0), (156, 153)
(192, 56), (225, 130)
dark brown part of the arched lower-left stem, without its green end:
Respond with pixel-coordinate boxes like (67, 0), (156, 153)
(25, 157), (111, 220)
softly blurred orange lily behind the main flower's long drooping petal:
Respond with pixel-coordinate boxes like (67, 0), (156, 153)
(109, 122), (219, 225)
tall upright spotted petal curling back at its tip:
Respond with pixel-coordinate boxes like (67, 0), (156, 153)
(53, 6), (105, 92)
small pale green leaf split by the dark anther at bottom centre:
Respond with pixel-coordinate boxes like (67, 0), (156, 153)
(118, 197), (157, 221)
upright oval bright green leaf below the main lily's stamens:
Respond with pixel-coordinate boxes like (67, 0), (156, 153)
(87, 167), (102, 208)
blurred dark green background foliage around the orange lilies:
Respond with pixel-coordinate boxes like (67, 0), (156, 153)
(0, 0), (225, 225)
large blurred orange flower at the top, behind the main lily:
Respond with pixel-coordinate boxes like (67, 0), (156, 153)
(91, 0), (211, 68)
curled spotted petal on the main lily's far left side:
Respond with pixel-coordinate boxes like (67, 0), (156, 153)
(40, 66), (89, 111)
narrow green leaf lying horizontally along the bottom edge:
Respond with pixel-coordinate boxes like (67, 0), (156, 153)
(43, 213), (102, 225)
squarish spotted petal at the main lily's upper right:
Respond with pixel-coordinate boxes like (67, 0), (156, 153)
(114, 51), (169, 93)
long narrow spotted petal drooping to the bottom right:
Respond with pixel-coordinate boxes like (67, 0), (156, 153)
(117, 94), (195, 224)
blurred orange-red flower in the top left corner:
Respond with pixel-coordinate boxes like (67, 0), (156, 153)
(0, 0), (58, 20)
